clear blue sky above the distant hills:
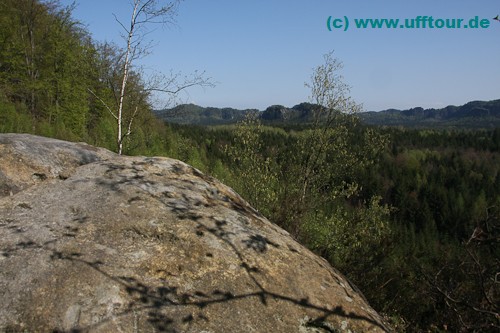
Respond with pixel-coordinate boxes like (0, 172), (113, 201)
(61, 0), (500, 111)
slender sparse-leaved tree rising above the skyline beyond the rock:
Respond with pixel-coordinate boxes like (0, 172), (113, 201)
(275, 53), (386, 235)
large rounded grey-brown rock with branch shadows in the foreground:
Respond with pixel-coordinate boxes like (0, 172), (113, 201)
(0, 134), (387, 333)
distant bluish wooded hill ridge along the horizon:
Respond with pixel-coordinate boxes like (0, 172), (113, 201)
(155, 99), (500, 128)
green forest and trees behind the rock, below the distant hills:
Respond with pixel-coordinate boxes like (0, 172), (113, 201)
(0, 0), (500, 332)
